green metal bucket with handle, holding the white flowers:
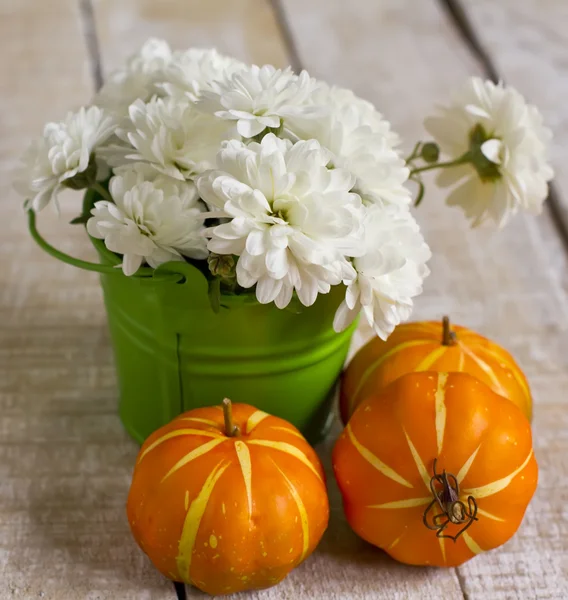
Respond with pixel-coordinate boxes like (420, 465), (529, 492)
(29, 199), (355, 443)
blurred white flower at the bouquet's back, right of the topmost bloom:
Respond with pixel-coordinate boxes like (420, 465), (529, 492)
(161, 48), (246, 102)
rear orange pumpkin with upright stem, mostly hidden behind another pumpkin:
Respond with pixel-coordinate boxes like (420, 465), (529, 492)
(340, 317), (532, 423)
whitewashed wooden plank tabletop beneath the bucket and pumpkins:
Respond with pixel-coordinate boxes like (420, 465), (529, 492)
(0, 0), (568, 600)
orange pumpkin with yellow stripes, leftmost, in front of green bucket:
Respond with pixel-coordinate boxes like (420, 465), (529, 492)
(127, 403), (329, 594)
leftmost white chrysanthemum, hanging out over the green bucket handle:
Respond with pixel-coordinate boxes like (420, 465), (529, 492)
(15, 106), (116, 211)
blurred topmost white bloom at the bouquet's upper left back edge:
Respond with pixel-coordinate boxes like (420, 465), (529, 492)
(94, 38), (174, 115)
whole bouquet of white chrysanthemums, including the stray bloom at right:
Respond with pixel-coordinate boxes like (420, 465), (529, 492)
(18, 40), (552, 440)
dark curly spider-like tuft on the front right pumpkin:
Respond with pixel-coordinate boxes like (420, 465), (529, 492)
(422, 459), (478, 542)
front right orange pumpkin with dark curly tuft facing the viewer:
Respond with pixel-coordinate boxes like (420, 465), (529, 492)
(333, 372), (538, 566)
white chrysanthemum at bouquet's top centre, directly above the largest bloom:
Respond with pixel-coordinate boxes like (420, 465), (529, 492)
(200, 65), (321, 138)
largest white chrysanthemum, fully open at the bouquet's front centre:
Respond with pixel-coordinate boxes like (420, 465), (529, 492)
(197, 134), (364, 308)
